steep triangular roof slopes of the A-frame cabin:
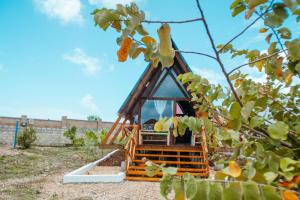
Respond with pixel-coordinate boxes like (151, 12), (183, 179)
(118, 39), (192, 116)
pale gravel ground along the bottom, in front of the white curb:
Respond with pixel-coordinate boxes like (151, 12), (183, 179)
(0, 171), (163, 200)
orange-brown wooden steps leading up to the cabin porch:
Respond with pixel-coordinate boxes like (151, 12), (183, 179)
(126, 145), (209, 181)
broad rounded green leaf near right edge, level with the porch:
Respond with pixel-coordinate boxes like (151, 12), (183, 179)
(268, 121), (289, 140)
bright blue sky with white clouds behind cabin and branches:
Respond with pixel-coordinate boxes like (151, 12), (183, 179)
(0, 0), (299, 121)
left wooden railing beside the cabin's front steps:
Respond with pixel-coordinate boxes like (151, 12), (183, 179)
(122, 125), (140, 172)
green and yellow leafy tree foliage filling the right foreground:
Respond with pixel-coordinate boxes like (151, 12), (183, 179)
(93, 0), (300, 199)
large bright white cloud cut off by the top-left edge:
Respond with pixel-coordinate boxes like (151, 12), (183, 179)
(33, 0), (83, 23)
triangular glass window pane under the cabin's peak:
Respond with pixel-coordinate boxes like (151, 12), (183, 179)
(153, 75), (185, 98)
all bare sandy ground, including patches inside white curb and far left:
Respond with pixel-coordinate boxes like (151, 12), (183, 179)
(0, 146), (163, 200)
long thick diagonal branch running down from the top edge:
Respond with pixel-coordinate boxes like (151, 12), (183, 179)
(196, 0), (243, 107)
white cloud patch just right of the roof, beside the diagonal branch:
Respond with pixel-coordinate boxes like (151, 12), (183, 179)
(192, 67), (225, 84)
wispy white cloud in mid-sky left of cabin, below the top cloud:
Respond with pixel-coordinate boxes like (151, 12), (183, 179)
(63, 48), (101, 75)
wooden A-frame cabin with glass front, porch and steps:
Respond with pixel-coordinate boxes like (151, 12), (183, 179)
(102, 41), (209, 181)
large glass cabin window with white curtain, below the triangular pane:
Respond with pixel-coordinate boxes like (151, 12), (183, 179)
(141, 100), (173, 130)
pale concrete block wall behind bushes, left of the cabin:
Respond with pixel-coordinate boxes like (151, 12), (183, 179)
(0, 115), (113, 146)
